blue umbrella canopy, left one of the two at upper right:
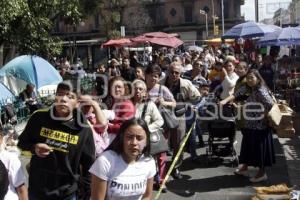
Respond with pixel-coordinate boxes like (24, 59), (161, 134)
(222, 21), (281, 39)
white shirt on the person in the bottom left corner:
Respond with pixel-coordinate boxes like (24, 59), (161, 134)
(0, 150), (26, 200)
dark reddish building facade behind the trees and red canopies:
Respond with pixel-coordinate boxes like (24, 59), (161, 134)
(54, 0), (244, 67)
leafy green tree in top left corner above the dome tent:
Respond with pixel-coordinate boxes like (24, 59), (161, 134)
(0, 0), (84, 66)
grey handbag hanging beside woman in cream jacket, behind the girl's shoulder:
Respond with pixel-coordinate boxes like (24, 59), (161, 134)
(141, 103), (169, 155)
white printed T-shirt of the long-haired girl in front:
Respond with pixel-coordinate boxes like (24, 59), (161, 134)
(89, 151), (156, 200)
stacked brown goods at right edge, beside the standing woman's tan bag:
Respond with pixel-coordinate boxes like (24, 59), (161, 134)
(276, 102), (296, 137)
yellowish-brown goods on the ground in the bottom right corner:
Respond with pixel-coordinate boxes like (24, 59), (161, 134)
(251, 183), (292, 200)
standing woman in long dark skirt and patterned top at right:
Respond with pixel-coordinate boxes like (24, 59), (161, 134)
(221, 69), (275, 183)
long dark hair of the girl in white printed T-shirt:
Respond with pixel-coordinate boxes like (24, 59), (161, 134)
(105, 118), (150, 157)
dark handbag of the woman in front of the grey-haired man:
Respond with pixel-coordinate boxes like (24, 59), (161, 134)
(158, 85), (179, 129)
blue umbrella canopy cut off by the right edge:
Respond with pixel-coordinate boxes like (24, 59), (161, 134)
(258, 27), (300, 46)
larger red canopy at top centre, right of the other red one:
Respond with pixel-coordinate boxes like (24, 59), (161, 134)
(131, 32), (183, 48)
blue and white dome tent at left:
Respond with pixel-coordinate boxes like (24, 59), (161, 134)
(0, 55), (62, 95)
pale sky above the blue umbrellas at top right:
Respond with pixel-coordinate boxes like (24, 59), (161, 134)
(241, 0), (291, 20)
